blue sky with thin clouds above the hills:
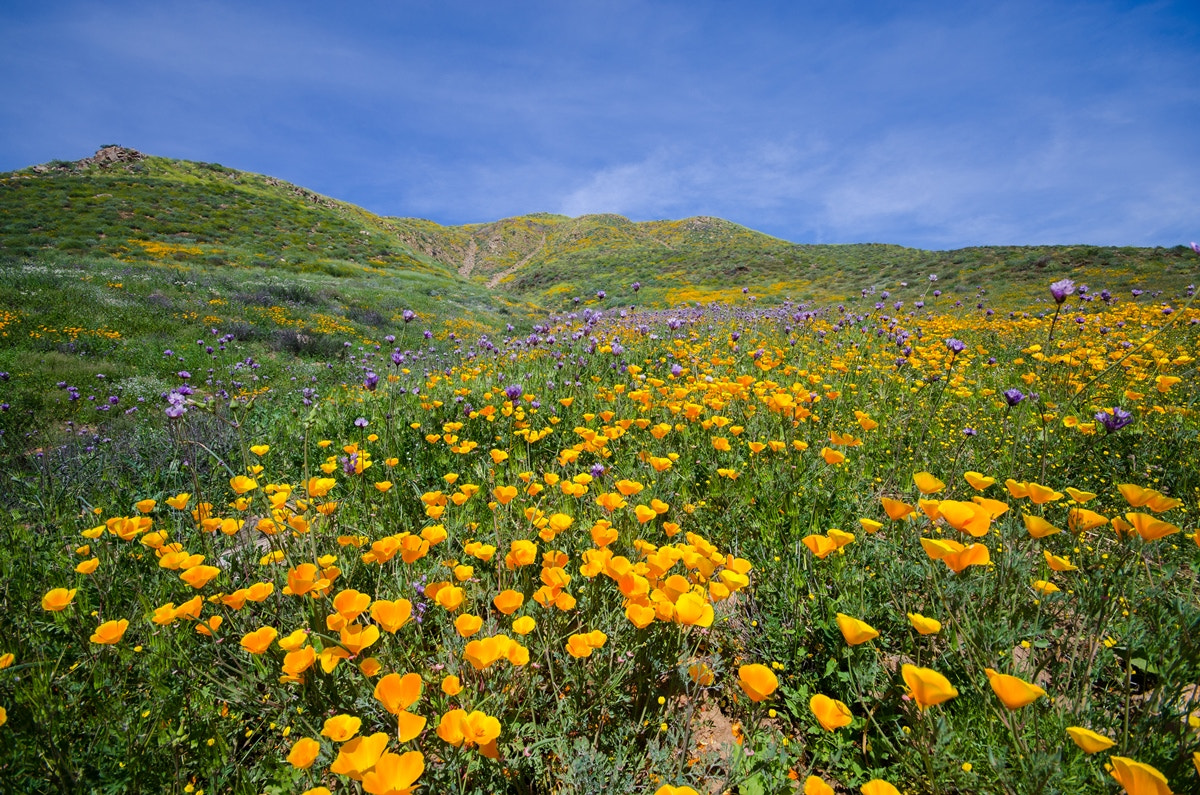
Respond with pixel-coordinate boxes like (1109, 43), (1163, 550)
(0, 0), (1200, 249)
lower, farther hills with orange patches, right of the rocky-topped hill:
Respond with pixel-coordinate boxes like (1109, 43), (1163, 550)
(390, 214), (1195, 309)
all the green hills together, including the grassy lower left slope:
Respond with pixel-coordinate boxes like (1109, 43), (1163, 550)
(0, 147), (1195, 437)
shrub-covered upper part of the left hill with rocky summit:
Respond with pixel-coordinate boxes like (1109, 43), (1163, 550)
(0, 147), (449, 275)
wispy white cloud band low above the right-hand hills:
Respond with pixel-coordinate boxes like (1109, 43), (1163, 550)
(557, 100), (1200, 247)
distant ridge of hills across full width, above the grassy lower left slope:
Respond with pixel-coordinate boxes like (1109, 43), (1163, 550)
(0, 147), (1192, 309)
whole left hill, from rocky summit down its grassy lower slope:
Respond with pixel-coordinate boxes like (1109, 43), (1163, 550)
(0, 148), (530, 440)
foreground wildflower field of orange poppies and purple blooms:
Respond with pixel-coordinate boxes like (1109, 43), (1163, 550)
(0, 259), (1200, 795)
